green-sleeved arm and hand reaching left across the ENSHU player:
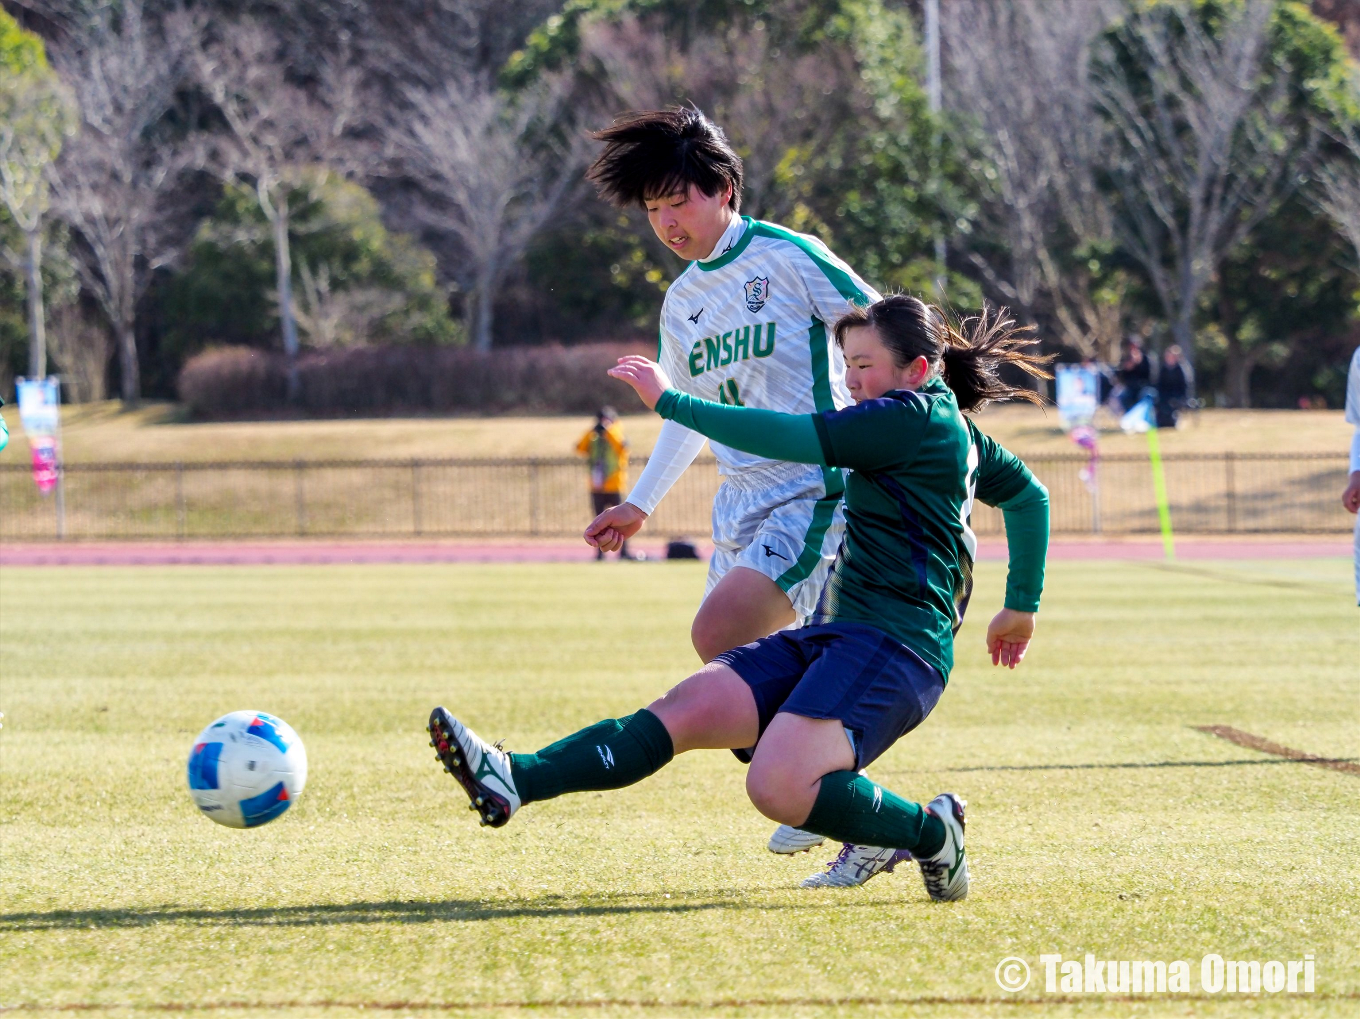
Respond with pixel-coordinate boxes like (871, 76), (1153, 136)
(609, 356), (826, 467)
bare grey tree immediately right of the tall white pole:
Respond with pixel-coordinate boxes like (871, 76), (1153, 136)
(941, 0), (1122, 359)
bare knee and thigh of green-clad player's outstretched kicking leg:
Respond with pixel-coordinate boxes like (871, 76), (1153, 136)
(647, 663), (760, 754)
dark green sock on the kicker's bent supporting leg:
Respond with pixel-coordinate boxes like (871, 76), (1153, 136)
(800, 771), (945, 857)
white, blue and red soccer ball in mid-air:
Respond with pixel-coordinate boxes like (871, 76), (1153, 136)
(189, 712), (307, 829)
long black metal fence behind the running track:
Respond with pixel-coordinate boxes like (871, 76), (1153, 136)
(0, 453), (1352, 541)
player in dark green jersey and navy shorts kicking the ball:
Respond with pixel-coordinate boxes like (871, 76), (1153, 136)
(430, 297), (1049, 899)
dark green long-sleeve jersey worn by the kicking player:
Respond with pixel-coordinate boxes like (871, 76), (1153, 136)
(657, 380), (1049, 679)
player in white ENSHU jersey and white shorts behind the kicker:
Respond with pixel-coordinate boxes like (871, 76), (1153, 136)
(585, 109), (900, 884)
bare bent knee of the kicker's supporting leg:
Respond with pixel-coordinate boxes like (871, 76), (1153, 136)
(747, 712), (854, 826)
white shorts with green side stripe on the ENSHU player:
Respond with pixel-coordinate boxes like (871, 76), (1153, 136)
(703, 464), (846, 623)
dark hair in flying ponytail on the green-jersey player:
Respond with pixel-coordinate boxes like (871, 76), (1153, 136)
(835, 294), (1054, 411)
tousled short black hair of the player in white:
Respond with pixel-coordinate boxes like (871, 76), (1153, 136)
(586, 106), (741, 211)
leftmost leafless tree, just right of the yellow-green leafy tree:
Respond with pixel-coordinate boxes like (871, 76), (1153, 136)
(52, 0), (197, 404)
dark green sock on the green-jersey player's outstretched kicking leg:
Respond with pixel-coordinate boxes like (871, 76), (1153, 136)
(510, 707), (675, 803)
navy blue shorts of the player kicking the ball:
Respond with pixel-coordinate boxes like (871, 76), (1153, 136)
(714, 623), (944, 770)
